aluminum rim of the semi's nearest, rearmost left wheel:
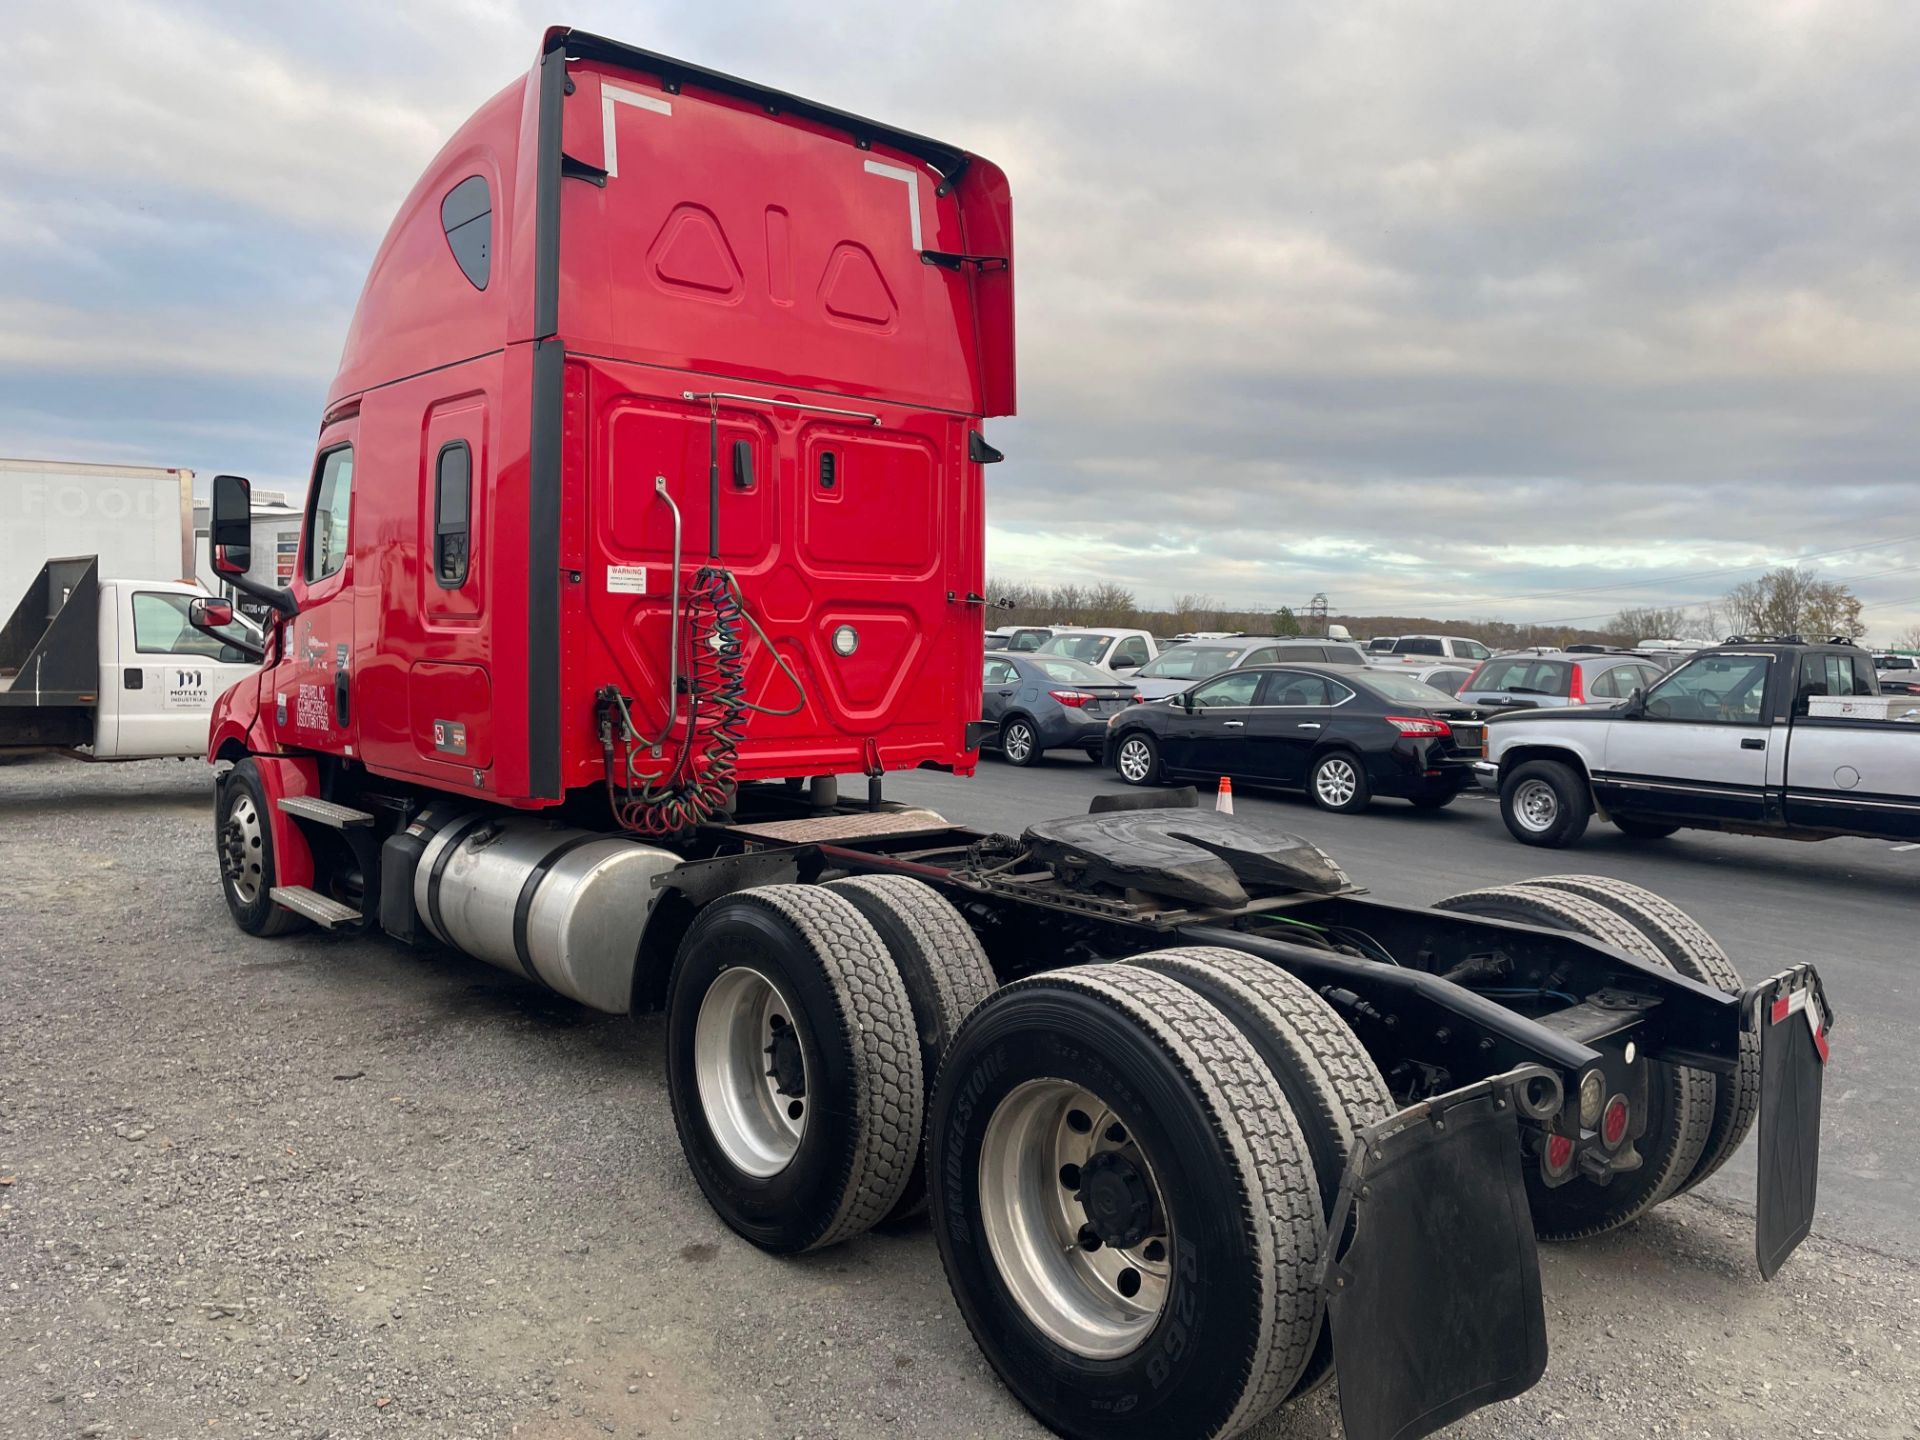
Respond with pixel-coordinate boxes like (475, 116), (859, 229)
(979, 1079), (1175, 1359)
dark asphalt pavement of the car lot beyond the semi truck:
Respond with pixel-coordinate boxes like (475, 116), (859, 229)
(875, 753), (1920, 1260)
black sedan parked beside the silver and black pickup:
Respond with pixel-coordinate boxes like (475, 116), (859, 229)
(1104, 664), (1486, 810)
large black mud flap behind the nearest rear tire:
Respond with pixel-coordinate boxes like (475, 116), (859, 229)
(1323, 1066), (1561, 1440)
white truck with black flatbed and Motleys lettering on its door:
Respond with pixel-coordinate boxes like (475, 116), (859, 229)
(0, 555), (261, 760)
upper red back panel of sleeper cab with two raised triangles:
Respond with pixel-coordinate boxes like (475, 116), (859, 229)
(559, 61), (998, 415)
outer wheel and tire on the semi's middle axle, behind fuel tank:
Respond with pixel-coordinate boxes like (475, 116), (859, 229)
(666, 885), (924, 1254)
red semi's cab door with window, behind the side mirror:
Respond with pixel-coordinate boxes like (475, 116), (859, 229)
(273, 439), (355, 755)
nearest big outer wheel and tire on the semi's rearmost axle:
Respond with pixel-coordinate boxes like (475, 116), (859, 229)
(929, 966), (1323, 1440)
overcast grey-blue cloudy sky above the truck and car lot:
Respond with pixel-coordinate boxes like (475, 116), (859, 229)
(0, 0), (1920, 636)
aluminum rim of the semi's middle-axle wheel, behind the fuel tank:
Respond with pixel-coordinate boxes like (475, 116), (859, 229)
(693, 966), (810, 1179)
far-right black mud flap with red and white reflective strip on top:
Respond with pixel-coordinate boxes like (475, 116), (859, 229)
(1741, 966), (1834, 1281)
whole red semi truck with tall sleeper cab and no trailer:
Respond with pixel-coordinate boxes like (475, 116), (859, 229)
(198, 29), (1830, 1440)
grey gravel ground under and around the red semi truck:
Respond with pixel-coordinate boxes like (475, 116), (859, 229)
(0, 760), (1920, 1440)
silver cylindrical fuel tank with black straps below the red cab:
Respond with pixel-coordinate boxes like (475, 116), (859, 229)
(413, 816), (680, 1014)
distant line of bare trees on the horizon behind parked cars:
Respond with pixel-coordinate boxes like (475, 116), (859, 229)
(987, 564), (1873, 649)
